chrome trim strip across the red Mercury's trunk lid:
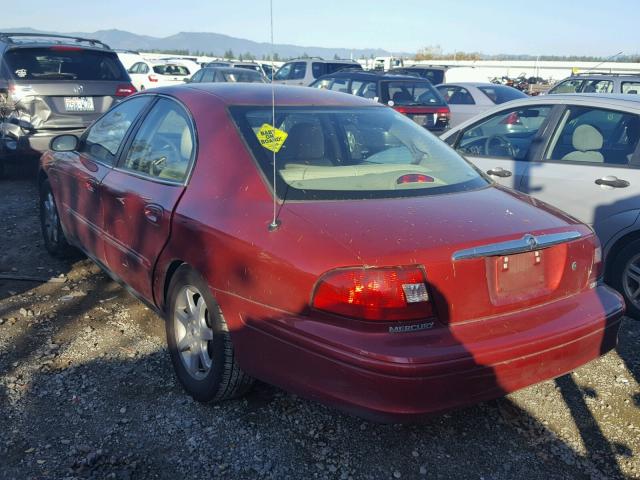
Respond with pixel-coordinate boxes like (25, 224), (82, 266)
(451, 231), (582, 261)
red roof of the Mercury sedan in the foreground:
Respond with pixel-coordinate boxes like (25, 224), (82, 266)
(170, 82), (387, 108)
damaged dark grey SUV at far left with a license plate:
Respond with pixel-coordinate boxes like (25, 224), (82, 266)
(0, 33), (136, 173)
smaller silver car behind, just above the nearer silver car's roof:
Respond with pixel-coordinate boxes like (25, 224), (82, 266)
(436, 82), (528, 127)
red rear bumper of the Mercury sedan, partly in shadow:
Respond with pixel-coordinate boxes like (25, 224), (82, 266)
(217, 286), (624, 422)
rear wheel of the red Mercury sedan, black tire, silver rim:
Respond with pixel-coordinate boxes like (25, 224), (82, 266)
(165, 265), (253, 402)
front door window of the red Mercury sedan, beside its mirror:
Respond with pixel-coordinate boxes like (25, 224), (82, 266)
(78, 96), (150, 165)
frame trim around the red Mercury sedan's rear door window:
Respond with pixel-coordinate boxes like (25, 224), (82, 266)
(113, 94), (199, 186)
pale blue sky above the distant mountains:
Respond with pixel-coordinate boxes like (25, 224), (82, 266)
(0, 0), (640, 56)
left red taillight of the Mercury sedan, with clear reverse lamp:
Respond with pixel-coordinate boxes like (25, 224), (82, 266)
(312, 266), (433, 321)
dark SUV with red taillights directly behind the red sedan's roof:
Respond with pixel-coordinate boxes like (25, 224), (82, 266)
(310, 72), (451, 133)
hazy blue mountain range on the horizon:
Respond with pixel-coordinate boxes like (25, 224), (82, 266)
(0, 28), (400, 59)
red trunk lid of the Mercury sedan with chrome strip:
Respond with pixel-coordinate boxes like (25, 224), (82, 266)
(287, 187), (597, 324)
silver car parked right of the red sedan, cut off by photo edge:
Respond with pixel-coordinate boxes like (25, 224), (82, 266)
(442, 94), (640, 319)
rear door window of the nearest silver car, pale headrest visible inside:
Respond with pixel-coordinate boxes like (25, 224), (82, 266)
(545, 105), (640, 165)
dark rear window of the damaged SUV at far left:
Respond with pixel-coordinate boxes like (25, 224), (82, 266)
(5, 46), (129, 82)
